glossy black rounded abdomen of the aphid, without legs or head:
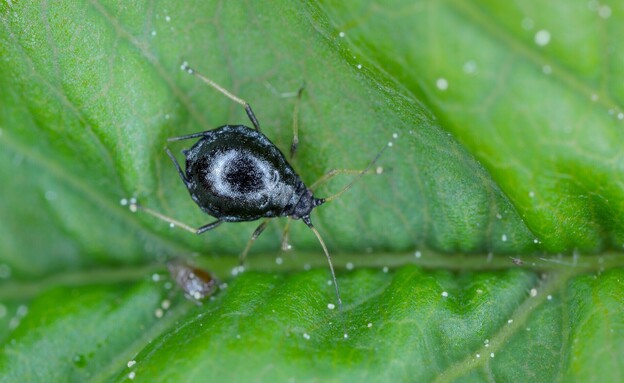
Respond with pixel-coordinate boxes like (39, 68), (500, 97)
(186, 125), (305, 222)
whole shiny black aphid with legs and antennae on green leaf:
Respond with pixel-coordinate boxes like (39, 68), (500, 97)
(131, 63), (385, 306)
